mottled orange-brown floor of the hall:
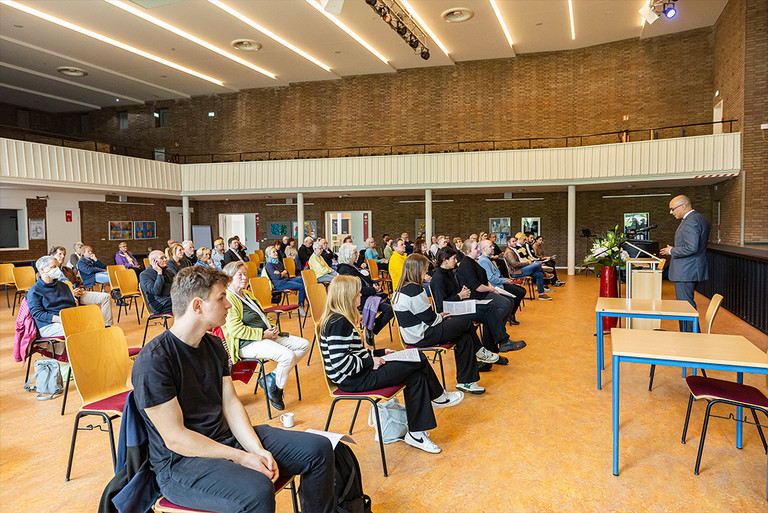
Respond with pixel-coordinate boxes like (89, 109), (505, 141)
(0, 276), (768, 513)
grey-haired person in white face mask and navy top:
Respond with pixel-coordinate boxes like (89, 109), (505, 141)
(27, 255), (77, 337)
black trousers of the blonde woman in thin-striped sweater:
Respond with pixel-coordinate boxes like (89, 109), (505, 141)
(339, 354), (443, 431)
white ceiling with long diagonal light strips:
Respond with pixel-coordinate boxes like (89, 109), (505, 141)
(0, 0), (727, 112)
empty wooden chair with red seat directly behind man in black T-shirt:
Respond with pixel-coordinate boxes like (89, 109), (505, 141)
(66, 327), (131, 481)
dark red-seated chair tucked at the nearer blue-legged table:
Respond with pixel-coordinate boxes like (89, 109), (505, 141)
(682, 376), (768, 499)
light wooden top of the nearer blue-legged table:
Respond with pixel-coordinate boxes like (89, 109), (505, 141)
(611, 328), (768, 369)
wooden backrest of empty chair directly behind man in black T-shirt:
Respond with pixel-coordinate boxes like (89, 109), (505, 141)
(67, 326), (131, 404)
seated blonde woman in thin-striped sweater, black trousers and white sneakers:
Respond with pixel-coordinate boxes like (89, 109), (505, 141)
(320, 276), (464, 454)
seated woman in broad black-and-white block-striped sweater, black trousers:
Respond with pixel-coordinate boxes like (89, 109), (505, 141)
(392, 253), (485, 395)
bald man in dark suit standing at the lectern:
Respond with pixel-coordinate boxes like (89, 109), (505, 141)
(661, 196), (709, 331)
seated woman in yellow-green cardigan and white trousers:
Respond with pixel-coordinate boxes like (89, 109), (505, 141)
(221, 262), (309, 410)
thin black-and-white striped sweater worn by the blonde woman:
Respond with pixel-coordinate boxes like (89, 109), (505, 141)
(320, 314), (373, 384)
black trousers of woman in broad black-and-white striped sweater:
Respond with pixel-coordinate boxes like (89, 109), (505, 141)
(413, 315), (480, 383)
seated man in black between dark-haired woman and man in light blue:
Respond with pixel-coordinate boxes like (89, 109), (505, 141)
(456, 237), (525, 353)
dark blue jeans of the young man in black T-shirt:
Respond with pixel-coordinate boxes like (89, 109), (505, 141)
(157, 425), (336, 513)
